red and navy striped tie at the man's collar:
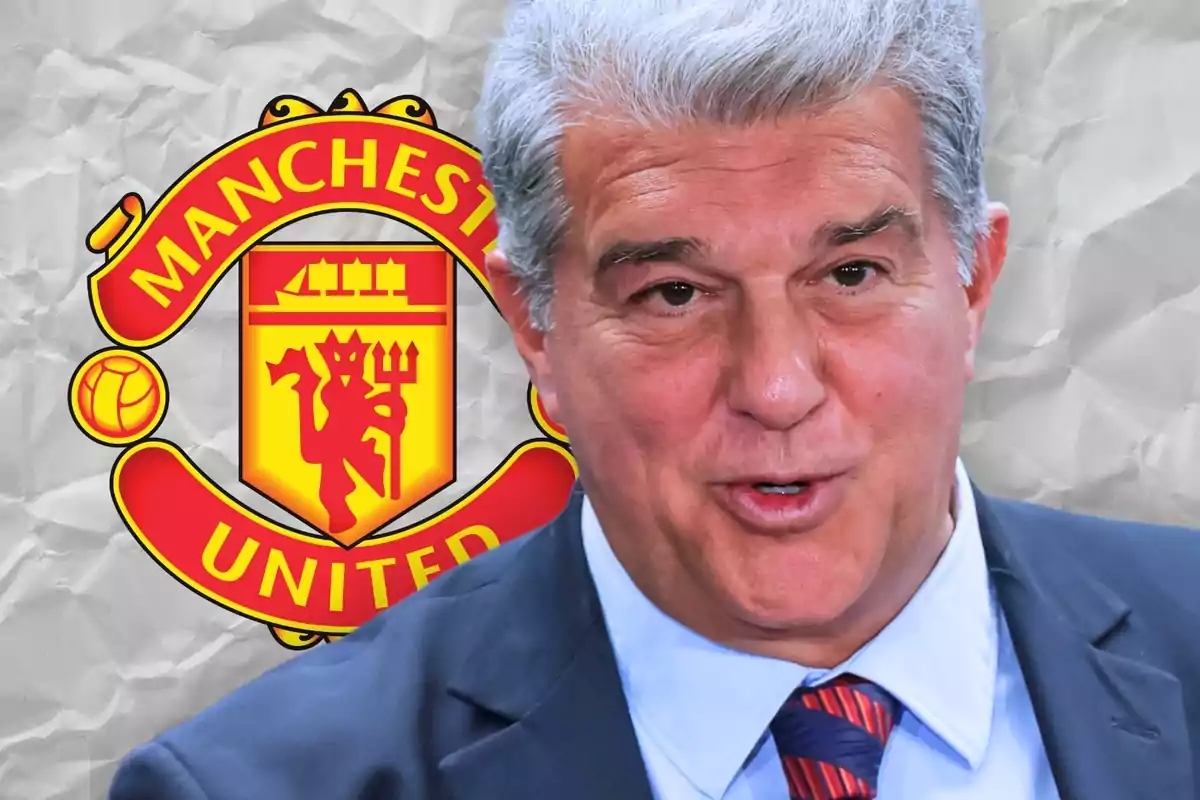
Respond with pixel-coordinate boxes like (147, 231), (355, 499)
(770, 675), (900, 800)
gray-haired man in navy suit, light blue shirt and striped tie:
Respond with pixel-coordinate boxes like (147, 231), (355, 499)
(110, 0), (1200, 800)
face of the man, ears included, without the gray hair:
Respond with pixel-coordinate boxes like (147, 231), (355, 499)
(490, 88), (1007, 657)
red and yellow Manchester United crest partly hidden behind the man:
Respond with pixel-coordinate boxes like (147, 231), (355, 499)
(70, 90), (576, 648)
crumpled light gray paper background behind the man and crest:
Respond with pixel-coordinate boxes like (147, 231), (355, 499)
(0, 0), (1200, 800)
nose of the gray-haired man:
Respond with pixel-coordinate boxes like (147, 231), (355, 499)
(728, 297), (826, 431)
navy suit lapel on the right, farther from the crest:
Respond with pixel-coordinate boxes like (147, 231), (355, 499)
(976, 491), (1194, 800)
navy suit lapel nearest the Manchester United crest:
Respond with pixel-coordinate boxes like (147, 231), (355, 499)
(439, 488), (650, 800)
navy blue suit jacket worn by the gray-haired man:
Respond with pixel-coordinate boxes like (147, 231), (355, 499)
(109, 491), (1200, 800)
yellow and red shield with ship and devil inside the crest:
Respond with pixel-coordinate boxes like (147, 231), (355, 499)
(241, 243), (455, 547)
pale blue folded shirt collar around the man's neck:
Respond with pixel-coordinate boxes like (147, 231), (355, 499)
(582, 461), (997, 798)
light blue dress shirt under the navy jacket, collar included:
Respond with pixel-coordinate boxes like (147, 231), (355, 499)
(583, 462), (1058, 800)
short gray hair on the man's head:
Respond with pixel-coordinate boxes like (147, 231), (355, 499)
(478, 0), (988, 330)
